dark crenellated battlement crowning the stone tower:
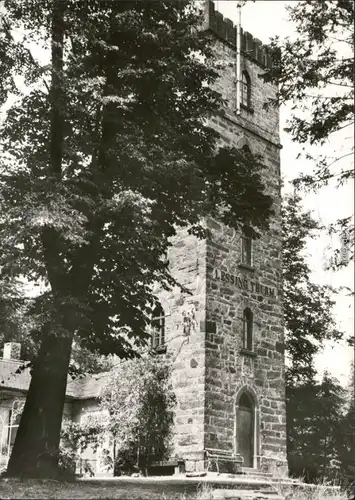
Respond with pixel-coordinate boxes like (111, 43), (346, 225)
(208, 0), (273, 69)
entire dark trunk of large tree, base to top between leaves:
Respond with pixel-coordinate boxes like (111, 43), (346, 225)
(7, 0), (70, 477)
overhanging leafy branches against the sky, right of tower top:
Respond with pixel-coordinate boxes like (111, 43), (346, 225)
(267, 0), (354, 184)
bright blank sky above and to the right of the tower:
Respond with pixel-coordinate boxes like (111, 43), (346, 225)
(215, 0), (354, 385)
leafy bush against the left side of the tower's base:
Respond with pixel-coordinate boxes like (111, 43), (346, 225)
(101, 356), (175, 468)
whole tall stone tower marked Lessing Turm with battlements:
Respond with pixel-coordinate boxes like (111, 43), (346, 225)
(156, 2), (287, 473)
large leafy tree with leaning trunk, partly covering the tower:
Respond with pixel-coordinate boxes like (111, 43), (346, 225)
(0, 0), (272, 475)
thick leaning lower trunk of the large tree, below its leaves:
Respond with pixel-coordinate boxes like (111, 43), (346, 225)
(7, 333), (73, 478)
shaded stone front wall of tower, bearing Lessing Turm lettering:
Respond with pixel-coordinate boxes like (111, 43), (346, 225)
(205, 25), (287, 471)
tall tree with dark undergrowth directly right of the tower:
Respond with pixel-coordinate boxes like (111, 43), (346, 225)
(282, 194), (352, 482)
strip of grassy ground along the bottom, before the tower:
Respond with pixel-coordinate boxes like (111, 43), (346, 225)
(0, 478), (346, 500)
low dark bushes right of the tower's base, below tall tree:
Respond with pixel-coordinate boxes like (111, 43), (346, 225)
(287, 374), (345, 482)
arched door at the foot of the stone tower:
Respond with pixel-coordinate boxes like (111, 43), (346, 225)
(236, 392), (255, 467)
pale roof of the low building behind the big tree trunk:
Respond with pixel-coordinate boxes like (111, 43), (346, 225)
(0, 359), (109, 399)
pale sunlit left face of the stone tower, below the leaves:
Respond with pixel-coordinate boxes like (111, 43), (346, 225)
(156, 230), (206, 469)
